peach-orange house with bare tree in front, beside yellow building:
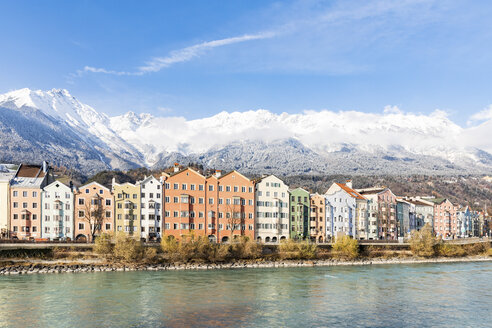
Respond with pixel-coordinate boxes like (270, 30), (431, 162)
(74, 182), (114, 241)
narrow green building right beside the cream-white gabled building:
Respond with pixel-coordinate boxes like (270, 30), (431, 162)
(290, 188), (310, 240)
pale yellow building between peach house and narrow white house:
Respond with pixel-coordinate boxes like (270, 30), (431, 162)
(112, 178), (142, 238)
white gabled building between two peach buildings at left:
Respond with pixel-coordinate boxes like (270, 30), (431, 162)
(41, 181), (74, 240)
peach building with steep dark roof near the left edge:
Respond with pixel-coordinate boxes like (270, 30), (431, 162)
(10, 162), (54, 239)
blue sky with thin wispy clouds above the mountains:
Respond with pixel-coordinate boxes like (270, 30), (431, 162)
(0, 0), (492, 125)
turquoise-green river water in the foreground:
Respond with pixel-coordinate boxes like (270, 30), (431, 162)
(0, 262), (492, 327)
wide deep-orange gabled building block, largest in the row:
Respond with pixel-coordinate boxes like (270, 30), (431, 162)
(162, 165), (254, 242)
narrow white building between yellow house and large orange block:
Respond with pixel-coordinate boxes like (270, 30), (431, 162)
(137, 175), (162, 240)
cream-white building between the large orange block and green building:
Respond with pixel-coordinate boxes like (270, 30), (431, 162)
(255, 175), (289, 243)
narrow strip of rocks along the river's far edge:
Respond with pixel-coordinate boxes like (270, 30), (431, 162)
(0, 256), (492, 275)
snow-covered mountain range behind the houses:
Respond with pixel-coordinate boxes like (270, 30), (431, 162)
(0, 89), (492, 174)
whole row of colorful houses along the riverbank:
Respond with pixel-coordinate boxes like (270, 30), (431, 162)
(0, 162), (490, 243)
